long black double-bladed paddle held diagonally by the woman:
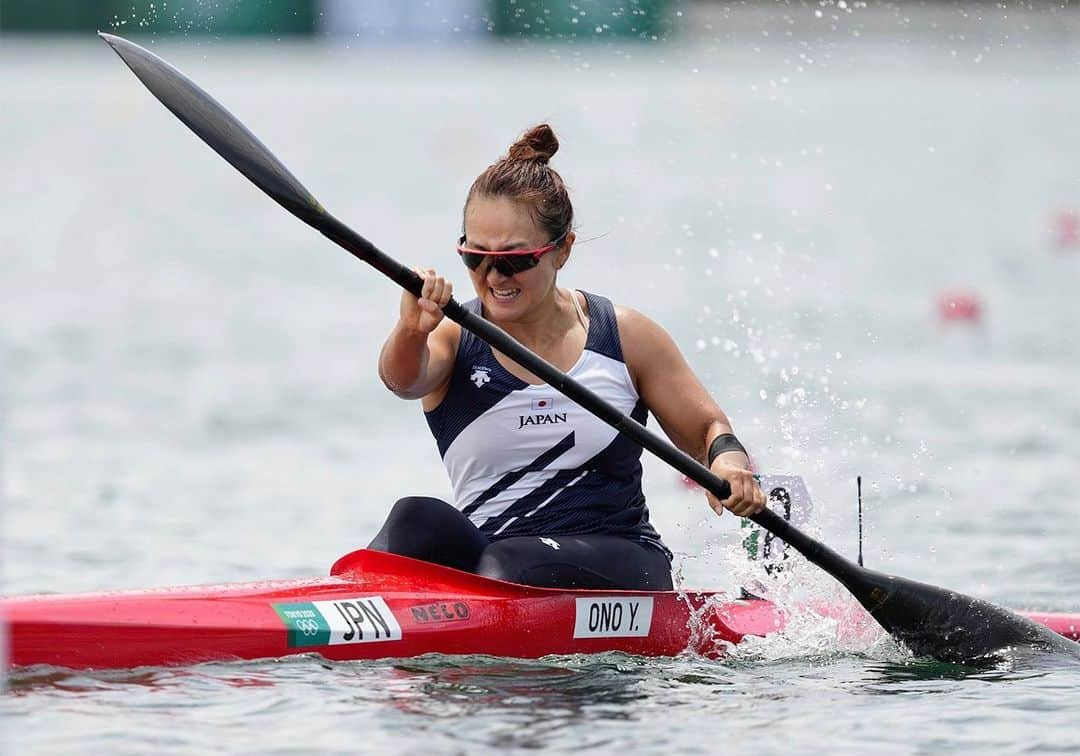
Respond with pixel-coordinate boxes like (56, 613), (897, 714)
(100, 33), (1080, 662)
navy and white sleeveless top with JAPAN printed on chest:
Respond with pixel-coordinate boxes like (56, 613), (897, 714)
(426, 292), (666, 551)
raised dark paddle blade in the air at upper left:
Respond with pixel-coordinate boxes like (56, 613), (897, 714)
(97, 31), (326, 224)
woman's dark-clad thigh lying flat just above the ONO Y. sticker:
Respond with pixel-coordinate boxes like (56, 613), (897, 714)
(476, 535), (672, 591)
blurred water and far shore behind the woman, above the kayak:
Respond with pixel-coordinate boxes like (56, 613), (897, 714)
(0, 0), (1080, 604)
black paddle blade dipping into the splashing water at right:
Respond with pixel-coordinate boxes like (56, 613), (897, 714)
(836, 567), (1080, 663)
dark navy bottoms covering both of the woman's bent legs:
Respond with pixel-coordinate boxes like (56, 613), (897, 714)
(368, 496), (672, 591)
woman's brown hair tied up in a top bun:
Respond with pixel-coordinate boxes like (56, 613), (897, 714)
(465, 123), (573, 239)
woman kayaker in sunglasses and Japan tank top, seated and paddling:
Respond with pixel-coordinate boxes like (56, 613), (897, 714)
(369, 124), (766, 590)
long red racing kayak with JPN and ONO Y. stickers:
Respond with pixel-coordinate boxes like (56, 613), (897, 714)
(0, 550), (1080, 669)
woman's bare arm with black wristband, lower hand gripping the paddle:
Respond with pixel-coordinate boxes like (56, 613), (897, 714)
(616, 308), (765, 516)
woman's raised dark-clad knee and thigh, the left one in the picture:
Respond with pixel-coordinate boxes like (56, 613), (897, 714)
(367, 496), (488, 572)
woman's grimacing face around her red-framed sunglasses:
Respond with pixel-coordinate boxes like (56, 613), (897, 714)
(464, 197), (573, 321)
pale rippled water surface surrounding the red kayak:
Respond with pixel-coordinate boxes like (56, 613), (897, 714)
(0, 14), (1080, 754)
